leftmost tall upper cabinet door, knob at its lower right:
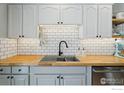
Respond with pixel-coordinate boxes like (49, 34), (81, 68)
(8, 5), (22, 38)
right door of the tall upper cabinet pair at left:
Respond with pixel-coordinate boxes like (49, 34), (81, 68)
(23, 5), (38, 38)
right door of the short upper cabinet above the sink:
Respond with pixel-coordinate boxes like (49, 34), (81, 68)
(61, 5), (83, 24)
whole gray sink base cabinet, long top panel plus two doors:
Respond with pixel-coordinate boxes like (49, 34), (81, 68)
(30, 67), (86, 85)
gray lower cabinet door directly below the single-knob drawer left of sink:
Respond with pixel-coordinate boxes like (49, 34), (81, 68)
(11, 75), (29, 85)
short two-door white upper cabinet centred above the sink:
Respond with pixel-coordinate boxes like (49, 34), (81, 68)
(39, 5), (82, 24)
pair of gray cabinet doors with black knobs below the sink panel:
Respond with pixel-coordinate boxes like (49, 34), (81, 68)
(30, 75), (85, 85)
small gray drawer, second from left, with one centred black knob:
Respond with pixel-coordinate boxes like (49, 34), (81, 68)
(12, 67), (28, 74)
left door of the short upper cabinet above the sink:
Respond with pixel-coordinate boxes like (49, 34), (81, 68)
(39, 5), (59, 24)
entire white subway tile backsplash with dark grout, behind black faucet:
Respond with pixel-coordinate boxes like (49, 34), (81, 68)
(0, 25), (115, 59)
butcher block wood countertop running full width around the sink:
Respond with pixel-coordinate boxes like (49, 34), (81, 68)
(0, 55), (124, 66)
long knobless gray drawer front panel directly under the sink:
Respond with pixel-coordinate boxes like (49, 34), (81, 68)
(30, 66), (86, 74)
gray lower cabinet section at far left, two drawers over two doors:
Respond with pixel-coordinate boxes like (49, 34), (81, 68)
(0, 66), (29, 85)
